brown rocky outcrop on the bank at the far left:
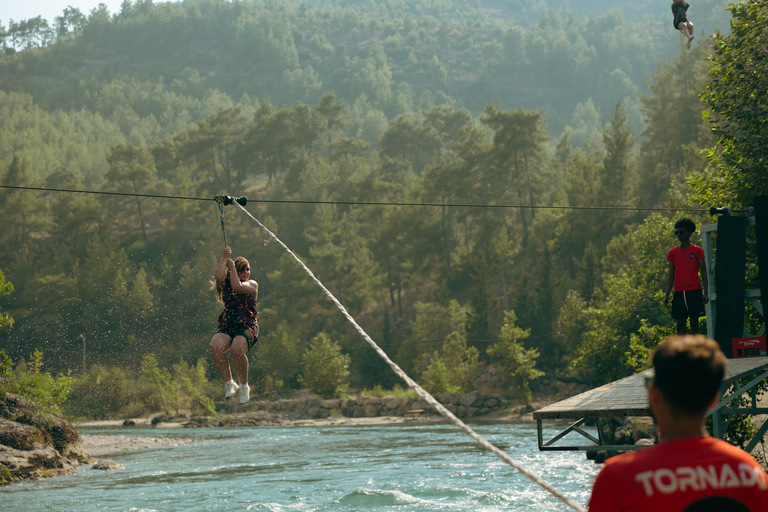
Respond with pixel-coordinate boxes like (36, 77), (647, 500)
(0, 393), (94, 484)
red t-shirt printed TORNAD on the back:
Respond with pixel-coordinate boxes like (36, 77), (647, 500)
(589, 437), (768, 512)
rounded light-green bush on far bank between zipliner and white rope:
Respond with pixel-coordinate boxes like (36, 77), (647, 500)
(299, 332), (351, 398)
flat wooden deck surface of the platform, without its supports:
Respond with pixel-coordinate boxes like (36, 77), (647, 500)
(533, 357), (768, 420)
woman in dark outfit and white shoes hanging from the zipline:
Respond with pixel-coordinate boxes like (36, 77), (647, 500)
(209, 246), (259, 404)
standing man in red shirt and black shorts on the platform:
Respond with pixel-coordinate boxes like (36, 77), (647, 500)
(664, 219), (709, 334)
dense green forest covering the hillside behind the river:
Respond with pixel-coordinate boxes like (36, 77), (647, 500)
(0, 0), (768, 408)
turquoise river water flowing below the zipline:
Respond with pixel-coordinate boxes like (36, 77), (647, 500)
(0, 424), (599, 512)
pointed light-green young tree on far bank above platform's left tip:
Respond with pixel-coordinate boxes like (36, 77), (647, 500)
(488, 310), (544, 404)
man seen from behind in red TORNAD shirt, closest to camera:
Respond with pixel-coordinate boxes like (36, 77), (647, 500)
(589, 335), (768, 512)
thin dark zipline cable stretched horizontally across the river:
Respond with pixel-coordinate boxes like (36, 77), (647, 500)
(0, 185), (709, 213)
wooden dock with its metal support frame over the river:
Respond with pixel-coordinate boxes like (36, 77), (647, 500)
(533, 357), (768, 450)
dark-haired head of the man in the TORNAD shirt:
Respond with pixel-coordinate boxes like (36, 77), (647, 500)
(653, 334), (726, 416)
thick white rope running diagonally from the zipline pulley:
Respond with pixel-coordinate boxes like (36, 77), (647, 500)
(234, 203), (587, 512)
